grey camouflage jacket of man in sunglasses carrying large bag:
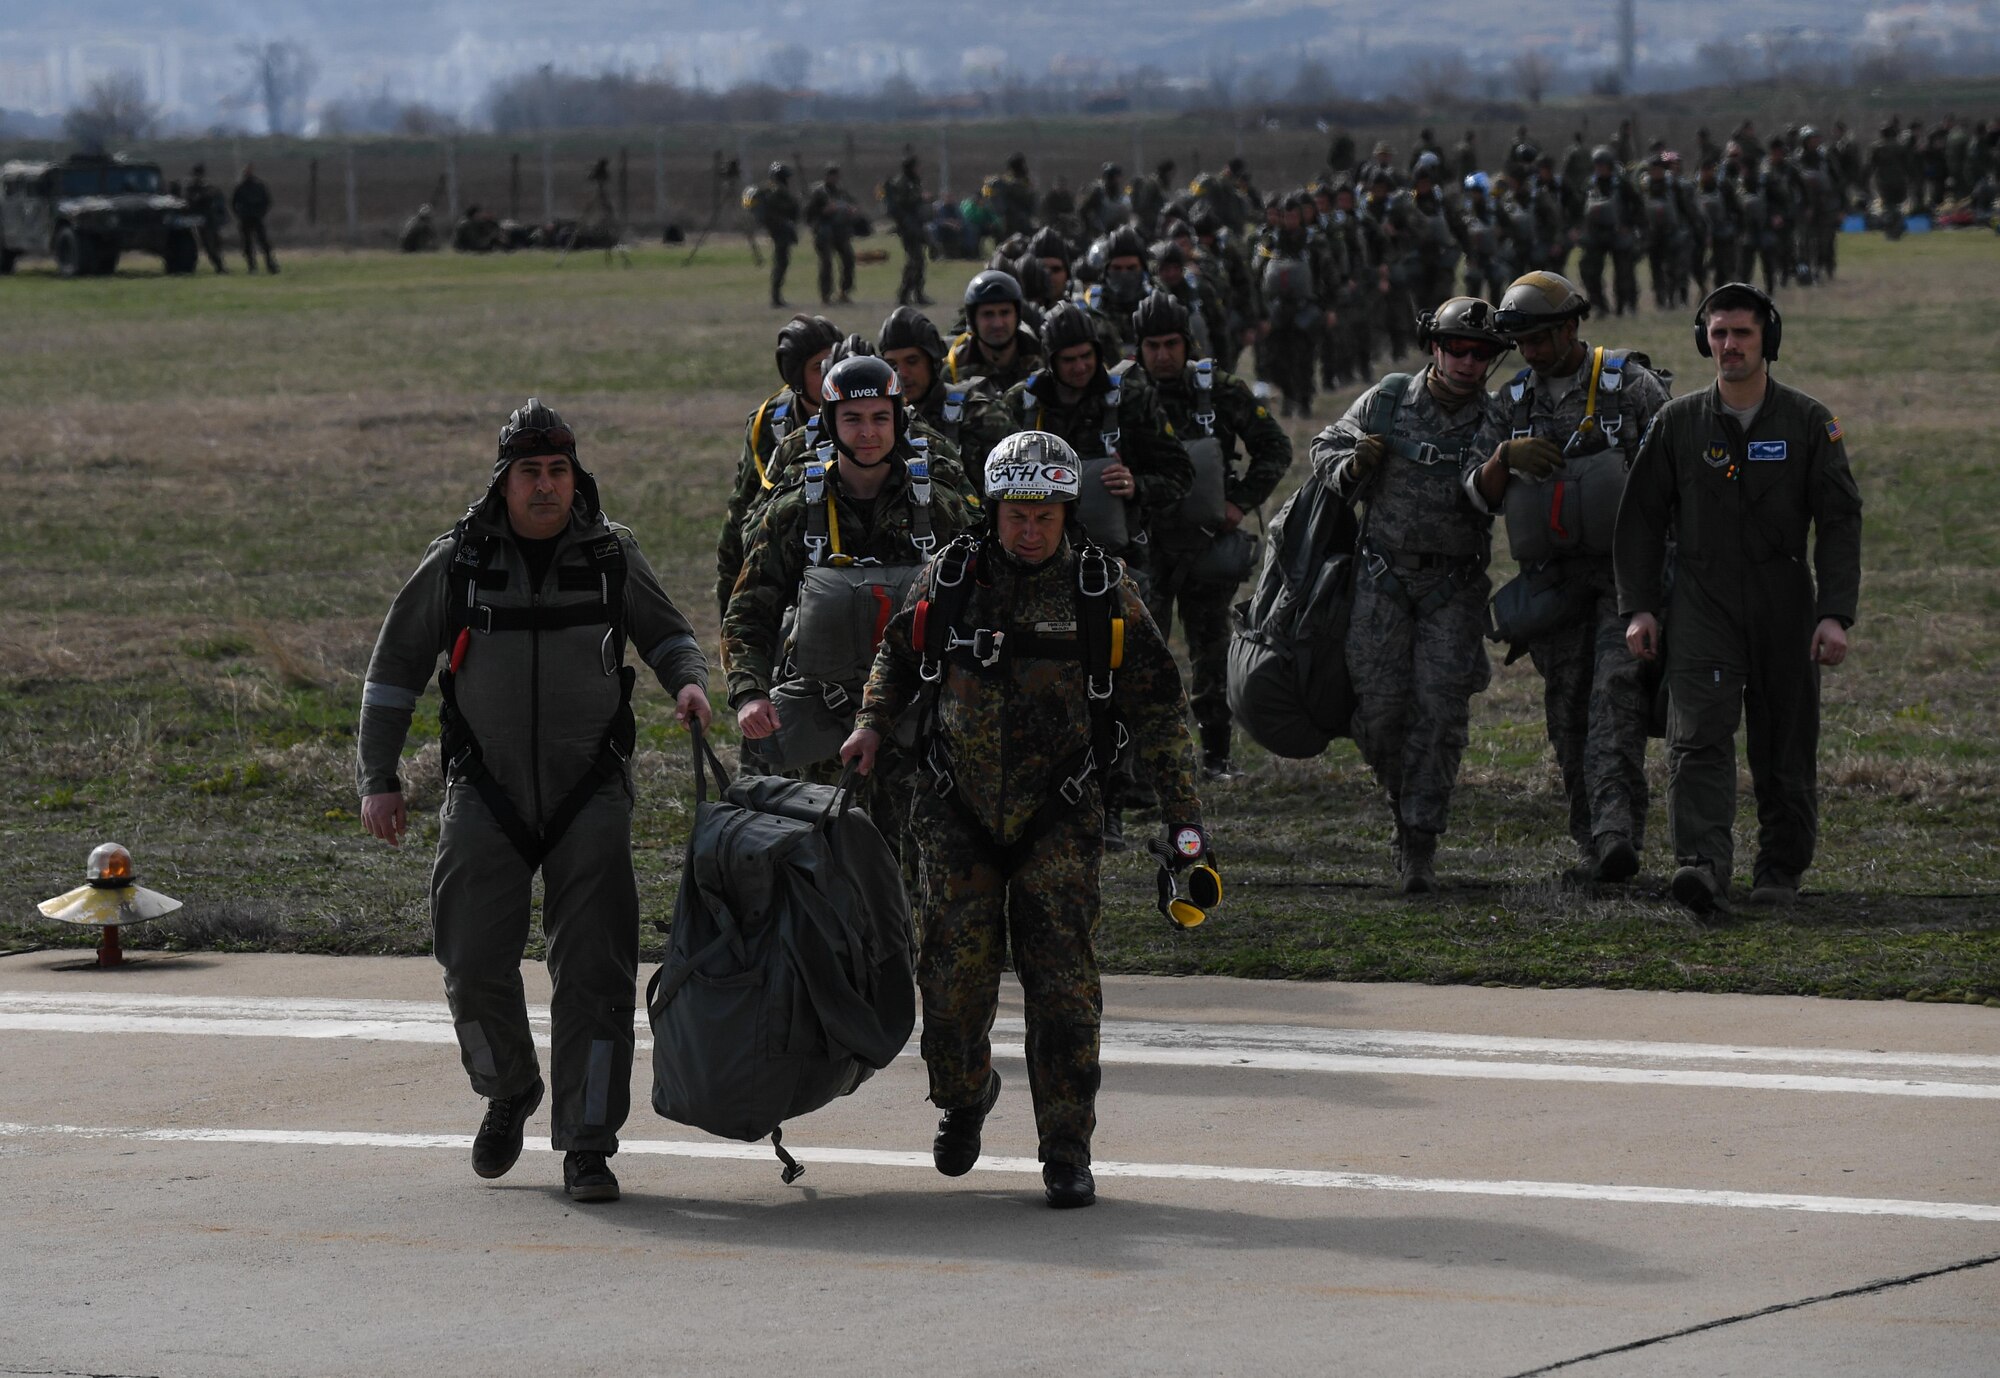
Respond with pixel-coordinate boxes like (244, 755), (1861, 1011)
(1312, 366), (1504, 566)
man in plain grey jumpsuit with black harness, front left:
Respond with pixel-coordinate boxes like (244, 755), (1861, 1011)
(356, 398), (708, 1202)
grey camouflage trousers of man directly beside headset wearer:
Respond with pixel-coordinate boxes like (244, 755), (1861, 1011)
(1528, 558), (1648, 856)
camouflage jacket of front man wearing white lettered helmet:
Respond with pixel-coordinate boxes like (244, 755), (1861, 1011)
(856, 540), (1202, 846)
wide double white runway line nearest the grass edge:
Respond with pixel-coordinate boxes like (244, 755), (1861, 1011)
(0, 992), (2000, 1100)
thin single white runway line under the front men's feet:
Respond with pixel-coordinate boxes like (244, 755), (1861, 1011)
(0, 1122), (2000, 1224)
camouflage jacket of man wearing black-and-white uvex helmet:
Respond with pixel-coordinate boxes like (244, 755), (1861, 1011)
(722, 458), (972, 708)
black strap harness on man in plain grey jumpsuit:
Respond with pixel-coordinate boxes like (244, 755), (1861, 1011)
(438, 516), (638, 870)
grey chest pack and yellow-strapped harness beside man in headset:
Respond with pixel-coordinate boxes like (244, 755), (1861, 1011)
(1504, 346), (1636, 564)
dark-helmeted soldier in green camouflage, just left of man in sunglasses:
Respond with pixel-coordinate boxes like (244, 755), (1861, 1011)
(1132, 292), (1292, 780)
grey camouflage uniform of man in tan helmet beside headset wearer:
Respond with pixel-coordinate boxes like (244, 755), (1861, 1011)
(1468, 340), (1668, 862)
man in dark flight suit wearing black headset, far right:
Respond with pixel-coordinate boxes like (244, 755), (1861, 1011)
(1616, 282), (1862, 914)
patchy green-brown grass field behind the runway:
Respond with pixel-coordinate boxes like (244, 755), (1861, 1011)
(0, 234), (2000, 1006)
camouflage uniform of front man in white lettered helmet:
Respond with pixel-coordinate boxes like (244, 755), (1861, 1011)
(858, 540), (1200, 1166)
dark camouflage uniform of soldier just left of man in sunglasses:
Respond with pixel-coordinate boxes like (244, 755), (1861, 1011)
(1146, 364), (1292, 764)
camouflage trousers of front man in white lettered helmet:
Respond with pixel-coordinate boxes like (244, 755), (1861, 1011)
(910, 790), (1104, 1164)
